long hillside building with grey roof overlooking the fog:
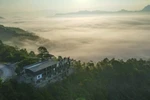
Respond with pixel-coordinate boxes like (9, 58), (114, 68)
(24, 58), (70, 84)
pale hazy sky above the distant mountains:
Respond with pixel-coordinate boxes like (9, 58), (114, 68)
(0, 0), (150, 12)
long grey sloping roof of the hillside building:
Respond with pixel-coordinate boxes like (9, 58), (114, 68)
(24, 60), (58, 72)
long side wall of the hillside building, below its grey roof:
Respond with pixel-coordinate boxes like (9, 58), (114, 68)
(26, 59), (70, 84)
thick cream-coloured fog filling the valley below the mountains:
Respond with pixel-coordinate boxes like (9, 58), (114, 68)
(0, 14), (150, 61)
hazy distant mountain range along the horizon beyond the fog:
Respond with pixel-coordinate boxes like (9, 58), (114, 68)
(56, 5), (150, 15)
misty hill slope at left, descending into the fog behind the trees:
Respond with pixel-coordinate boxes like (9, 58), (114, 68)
(0, 25), (54, 49)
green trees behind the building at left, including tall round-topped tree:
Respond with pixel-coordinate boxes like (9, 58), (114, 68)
(0, 40), (53, 75)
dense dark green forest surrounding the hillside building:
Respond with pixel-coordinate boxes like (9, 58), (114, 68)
(0, 41), (150, 100)
